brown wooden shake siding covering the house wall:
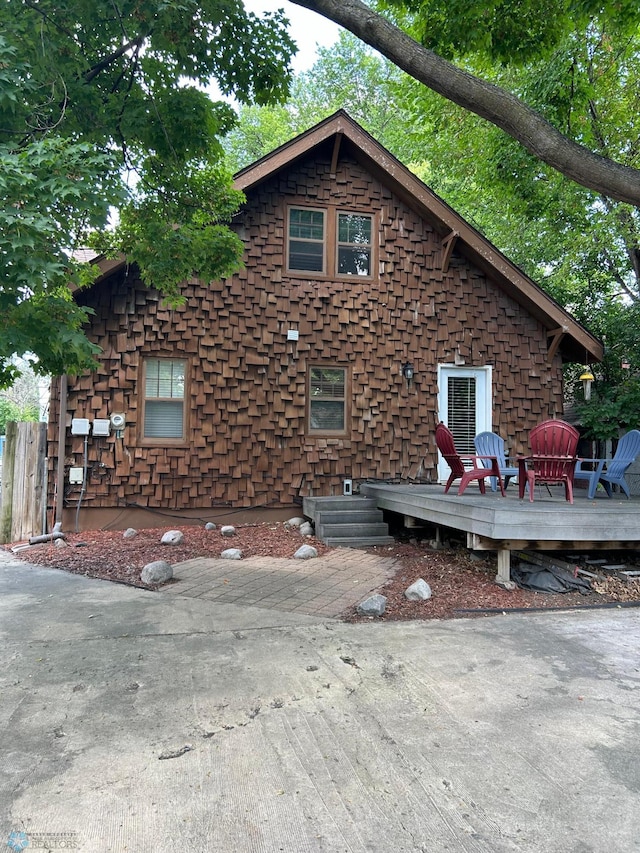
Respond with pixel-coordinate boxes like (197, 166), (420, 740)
(49, 113), (600, 526)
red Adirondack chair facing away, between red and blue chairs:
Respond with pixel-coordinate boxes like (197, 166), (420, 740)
(518, 419), (580, 503)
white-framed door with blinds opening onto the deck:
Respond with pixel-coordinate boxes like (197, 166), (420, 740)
(438, 364), (492, 483)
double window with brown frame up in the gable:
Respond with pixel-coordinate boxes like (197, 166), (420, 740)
(287, 207), (373, 277)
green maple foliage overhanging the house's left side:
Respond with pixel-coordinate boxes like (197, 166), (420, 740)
(0, 0), (295, 385)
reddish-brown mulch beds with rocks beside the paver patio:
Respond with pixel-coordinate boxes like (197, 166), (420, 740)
(3, 523), (640, 621)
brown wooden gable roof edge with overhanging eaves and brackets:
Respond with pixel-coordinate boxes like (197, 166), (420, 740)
(234, 110), (603, 364)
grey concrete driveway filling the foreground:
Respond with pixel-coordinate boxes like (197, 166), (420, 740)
(0, 555), (640, 853)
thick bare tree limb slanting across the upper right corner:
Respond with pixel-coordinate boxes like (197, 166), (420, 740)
(290, 0), (640, 207)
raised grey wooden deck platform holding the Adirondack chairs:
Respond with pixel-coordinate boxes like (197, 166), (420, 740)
(360, 483), (640, 586)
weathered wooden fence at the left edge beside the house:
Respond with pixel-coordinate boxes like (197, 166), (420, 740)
(0, 421), (47, 544)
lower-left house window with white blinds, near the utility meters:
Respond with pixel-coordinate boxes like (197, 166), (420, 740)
(142, 358), (187, 442)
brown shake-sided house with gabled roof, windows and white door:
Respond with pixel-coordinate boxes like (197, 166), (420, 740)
(49, 111), (601, 529)
